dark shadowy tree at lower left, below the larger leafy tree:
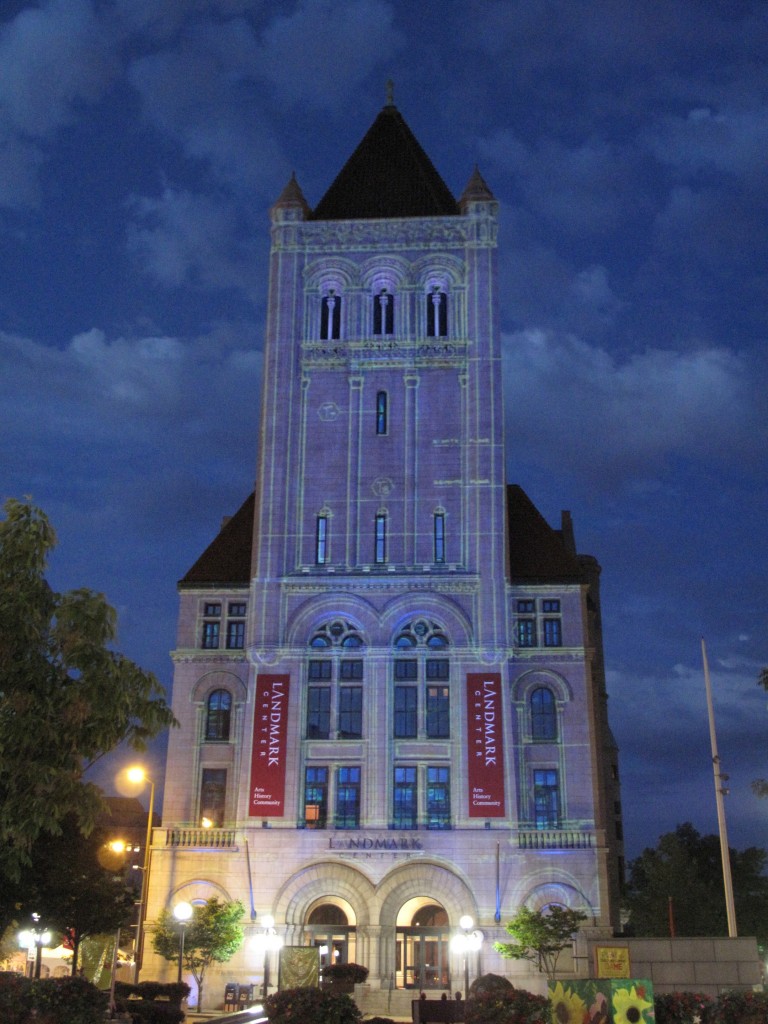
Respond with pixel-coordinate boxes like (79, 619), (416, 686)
(0, 815), (135, 974)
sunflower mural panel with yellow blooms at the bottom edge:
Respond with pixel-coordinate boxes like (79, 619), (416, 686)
(549, 978), (655, 1024)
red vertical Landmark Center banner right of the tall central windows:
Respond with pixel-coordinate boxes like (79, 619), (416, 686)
(467, 672), (505, 818)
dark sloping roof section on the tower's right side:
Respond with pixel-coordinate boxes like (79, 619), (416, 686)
(507, 483), (585, 583)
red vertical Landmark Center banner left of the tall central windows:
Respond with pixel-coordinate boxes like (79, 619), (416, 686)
(249, 675), (290, 818)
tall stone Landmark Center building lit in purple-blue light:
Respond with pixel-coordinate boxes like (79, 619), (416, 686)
(146, 103), (621, 1005)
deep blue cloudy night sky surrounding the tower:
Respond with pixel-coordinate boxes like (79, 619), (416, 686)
(0, 0), (768, 856)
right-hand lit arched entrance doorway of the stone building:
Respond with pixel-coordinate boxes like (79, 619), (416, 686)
(395, 896), (451, 991)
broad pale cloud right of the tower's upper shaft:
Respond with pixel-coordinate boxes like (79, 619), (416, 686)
(504, 329), (752, 488)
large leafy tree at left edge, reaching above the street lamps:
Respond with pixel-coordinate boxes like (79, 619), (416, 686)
(0, 499), (175, 880)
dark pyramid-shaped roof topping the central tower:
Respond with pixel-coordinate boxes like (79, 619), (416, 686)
(311, 103), (459, 220)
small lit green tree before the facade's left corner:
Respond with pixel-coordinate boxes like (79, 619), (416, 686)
(153, 896), (245, 1010)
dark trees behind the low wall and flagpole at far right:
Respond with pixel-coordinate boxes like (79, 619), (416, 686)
(625, 822), (768, 945)
